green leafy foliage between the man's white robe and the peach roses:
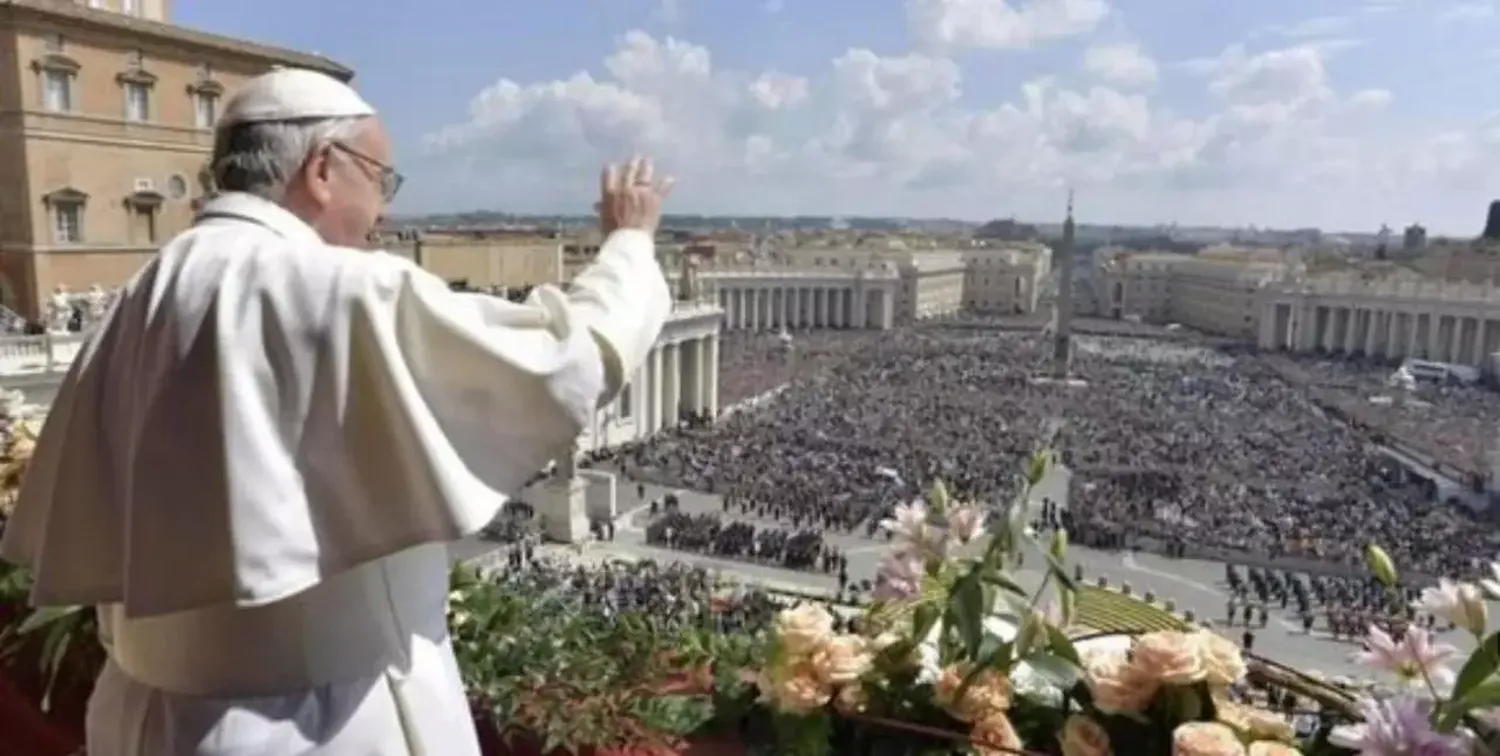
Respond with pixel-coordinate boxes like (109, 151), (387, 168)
(449, 567), (765, 750)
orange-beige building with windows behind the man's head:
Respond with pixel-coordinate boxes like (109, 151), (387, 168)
(0, 0), (353, 318)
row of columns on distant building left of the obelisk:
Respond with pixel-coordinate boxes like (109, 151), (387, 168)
(719, 281), (896, 330)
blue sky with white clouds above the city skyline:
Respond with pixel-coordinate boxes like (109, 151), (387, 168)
(173, 0), (1500, 236)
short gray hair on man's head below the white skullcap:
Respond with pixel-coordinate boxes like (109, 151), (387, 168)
(209, 117), (368, 203)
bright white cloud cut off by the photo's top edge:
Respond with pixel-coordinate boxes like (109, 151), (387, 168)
(906, 0), (1110, 50)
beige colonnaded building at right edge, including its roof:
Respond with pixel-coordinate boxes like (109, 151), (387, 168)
(1257, 272), (1500, 371)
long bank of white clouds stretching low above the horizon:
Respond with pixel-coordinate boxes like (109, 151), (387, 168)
(426, 32), (1500, 227)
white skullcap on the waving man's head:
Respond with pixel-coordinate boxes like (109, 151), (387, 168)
(218, 69), (375, 129)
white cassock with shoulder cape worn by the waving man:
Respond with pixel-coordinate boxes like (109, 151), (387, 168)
(0, 194), (672, 756)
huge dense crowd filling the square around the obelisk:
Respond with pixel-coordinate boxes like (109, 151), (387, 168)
(623, 326), (1494, 575)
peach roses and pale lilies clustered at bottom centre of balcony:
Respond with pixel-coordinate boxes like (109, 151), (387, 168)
(750, 447), (1320, 756)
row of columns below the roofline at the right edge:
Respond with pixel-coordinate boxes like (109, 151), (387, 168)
(1259, 302), (1500, 368)
